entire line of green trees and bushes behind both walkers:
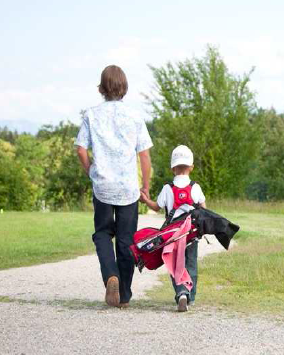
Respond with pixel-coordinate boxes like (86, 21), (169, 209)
(0, 47), (284, 210)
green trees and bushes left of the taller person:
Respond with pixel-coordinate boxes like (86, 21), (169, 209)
(0, 122), (92, 210)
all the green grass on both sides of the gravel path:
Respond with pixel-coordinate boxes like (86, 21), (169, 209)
(0, 207), (284, 314)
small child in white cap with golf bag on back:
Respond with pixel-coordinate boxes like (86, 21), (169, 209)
(140, 145), (206, 312)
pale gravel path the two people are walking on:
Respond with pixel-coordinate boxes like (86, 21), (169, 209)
(0, 215), (284, 355)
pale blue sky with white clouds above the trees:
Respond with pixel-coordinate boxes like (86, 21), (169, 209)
(0, 0), (284, 133)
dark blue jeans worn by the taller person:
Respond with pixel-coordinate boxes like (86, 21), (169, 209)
(93, 197), (138, 303)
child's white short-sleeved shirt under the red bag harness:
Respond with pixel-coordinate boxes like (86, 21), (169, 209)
(157, 175), (205, 218)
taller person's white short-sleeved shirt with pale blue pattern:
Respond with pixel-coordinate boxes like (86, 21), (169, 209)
(75, 101), (153, 206)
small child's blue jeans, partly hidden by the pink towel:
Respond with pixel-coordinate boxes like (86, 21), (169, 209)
(171, 242), (198, 303)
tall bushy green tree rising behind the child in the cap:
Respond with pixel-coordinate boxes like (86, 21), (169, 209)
(147, 47), (259, 197)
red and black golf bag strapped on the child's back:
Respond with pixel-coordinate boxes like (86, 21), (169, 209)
(130, 181), (240, 272)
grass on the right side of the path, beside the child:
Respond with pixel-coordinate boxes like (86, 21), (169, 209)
(146, 211), (284, 315)
